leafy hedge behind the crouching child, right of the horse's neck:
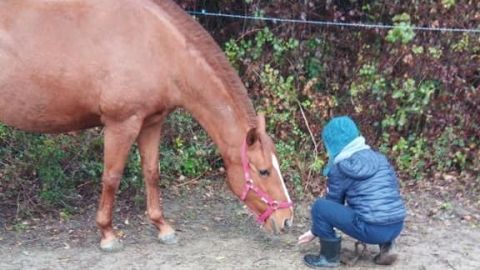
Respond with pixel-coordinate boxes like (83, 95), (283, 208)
(179, 0), (480, 194)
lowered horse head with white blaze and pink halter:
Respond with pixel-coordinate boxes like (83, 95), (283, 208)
(229, 115), (293, 234)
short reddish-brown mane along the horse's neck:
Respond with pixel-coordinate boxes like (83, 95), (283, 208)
(152, 0), (256, 127)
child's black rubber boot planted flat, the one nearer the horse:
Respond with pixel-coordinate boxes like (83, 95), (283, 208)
(303, 237), (342, 268)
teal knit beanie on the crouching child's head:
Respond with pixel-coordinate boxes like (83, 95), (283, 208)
(322, 116), (360, 161)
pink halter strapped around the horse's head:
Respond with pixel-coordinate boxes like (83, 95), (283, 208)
(240, 141), (293, 224)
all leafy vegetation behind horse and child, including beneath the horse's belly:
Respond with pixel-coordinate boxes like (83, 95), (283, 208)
(0, 0), (480, 219)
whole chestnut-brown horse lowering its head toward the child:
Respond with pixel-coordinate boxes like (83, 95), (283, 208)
(0, 0), (293, 251)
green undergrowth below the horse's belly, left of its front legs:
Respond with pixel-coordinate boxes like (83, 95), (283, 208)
(0, 125), (102, 213)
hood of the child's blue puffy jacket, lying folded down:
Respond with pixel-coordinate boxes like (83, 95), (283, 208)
(337, 150), (382, 180)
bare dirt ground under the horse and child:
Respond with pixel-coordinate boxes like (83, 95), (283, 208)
(0, 179), (480, 270)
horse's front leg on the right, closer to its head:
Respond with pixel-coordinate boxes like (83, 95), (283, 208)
(137, 119), (177, 244)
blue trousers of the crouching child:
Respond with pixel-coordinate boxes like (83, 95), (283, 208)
(312, 199), (403, 244)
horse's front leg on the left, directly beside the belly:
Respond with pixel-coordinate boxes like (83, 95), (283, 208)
(96, 116), (142, 252)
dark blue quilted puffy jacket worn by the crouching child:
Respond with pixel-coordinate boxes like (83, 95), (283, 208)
(326, 149), (406, 225)
